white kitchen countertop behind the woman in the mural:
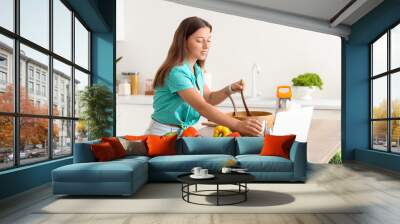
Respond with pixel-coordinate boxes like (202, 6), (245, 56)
(117, 95), (341, 110)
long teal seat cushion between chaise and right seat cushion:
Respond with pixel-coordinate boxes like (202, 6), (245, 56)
(149, 155), (235, 172)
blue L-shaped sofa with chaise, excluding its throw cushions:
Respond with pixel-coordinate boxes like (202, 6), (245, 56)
(52, 137), (307, 195)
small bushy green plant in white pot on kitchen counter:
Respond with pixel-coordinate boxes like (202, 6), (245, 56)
(292, 73), (323, 100)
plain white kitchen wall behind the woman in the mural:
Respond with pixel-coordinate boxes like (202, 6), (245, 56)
(117, 0), (341, 99)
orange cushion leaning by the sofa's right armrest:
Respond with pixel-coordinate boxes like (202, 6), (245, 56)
(260, 134), (296, 159)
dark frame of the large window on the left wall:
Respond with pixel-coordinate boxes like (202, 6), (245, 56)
(0, 0), (93, 172)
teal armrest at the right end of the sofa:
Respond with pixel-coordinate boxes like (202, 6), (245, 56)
(290, 142), (307, 181)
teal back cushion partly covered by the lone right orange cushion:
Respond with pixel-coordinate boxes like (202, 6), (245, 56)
(236, 137), (264, 155)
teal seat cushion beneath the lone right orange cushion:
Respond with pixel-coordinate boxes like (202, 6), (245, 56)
(236, 155), (293, 172)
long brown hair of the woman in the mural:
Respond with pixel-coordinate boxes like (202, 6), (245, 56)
(153, 16), (212, 89)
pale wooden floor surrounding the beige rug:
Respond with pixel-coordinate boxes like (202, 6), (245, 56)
(0, 163), (400, 224)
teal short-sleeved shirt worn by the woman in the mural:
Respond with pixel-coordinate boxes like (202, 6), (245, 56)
(151, 62), (204, 129)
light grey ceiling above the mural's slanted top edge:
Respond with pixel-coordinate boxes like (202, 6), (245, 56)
(167, 0), (383, 38)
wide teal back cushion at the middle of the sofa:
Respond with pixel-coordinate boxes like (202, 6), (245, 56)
(177, 137), (235, 155)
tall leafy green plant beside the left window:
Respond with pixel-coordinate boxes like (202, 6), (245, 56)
(79, 84), (113, 140)
